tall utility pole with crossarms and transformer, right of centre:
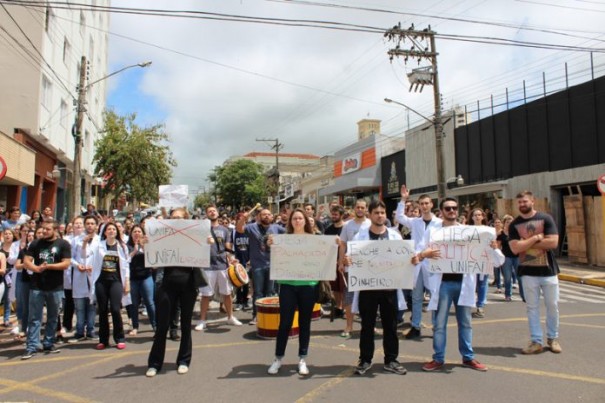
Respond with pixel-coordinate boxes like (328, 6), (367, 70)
(384, 24), (446, 200)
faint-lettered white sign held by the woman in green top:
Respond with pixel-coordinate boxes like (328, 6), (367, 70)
(270, 234), (338, 280)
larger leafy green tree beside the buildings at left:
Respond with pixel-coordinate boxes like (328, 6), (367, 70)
(93, 111), (177, 203)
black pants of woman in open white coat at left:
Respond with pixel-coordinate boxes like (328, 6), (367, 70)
(95, 279), (124, 345)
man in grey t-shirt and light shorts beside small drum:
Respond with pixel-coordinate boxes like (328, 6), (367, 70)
(195, 204), (242, 331)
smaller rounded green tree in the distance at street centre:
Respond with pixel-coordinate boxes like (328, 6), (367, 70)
(215, 159), (267, 208)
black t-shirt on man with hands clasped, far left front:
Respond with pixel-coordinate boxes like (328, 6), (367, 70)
(25, 238), (71, 291)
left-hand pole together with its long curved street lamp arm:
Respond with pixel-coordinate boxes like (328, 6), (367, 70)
(72, 56), (151, 218)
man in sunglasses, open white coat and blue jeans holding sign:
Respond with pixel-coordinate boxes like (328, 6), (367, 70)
(412, 197), (504, 371)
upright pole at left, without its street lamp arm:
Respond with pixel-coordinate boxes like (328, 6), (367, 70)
(71, 56), (87, 217)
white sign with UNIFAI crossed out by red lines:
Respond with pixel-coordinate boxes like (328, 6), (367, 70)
(145, 220), (210, 267)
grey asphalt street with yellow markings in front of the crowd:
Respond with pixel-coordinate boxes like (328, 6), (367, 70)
(0, 281), (605, 402)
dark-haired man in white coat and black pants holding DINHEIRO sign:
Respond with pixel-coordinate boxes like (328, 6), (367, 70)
(345, 200), (411, 375)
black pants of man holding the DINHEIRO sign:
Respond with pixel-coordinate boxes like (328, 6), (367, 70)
(359, 290), (399, 364)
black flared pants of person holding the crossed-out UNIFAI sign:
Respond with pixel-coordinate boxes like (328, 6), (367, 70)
(147, 276), (198, 371)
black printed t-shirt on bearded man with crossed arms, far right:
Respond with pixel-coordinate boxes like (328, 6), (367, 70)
(508, 212), (558, 277)
